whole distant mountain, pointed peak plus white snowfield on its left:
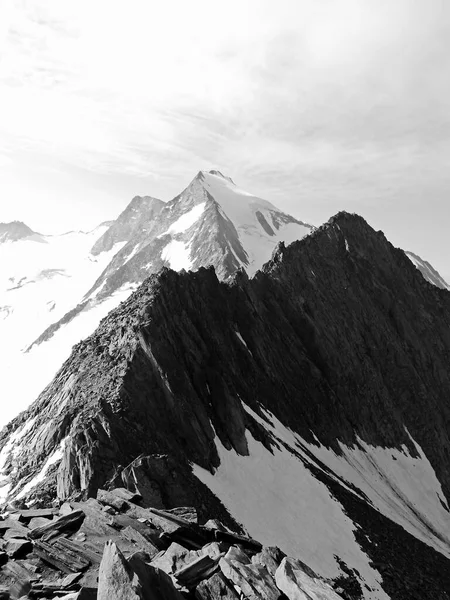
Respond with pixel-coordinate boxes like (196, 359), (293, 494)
(0, 171), (312, 424)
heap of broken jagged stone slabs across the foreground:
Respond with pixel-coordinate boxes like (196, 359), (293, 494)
(0, 488), (348, 600)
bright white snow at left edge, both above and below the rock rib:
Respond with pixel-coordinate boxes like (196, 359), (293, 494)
(0, 225), (127, 424)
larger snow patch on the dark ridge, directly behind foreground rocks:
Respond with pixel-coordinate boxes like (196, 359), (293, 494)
(193, 404), (389, 600)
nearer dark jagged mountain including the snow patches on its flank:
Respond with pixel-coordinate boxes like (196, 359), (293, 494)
(0, 207), (450, 600)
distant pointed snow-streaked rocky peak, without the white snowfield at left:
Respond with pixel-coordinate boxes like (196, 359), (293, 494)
(32, 170), (313, 344)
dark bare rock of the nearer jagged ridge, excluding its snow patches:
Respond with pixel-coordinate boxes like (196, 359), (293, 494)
(2, 213), (450, 598)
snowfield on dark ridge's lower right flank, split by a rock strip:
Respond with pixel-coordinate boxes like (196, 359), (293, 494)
(193, 403), (450, 600)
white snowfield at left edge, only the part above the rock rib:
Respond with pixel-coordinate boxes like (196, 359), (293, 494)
(0, 226), (119, 347)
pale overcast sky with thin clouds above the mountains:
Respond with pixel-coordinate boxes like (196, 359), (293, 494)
(0, 0), (450, 279)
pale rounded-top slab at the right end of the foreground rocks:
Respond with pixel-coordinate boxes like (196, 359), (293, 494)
(275, 558), (342, 600)
